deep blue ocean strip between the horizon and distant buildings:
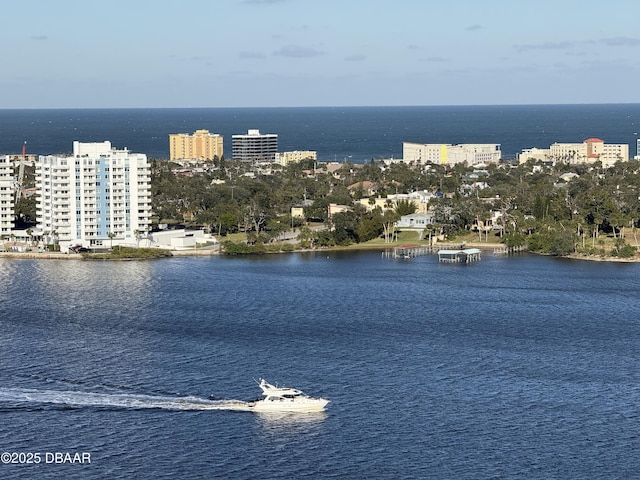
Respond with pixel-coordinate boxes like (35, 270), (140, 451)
(0, 104), (640, 159)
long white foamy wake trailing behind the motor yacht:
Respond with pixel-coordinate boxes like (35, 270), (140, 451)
(0, 388), (250, 411)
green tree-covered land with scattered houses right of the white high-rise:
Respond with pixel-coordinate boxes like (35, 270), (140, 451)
(152, 160), (640, 255)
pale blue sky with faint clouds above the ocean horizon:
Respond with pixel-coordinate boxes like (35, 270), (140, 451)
(0, 0), (640, 109)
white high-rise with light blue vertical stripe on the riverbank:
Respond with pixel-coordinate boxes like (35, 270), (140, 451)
(36, 142), (151, 251)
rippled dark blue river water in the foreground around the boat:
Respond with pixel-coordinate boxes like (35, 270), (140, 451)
(0, 252), (640, 479)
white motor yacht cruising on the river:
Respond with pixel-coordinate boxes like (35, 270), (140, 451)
(249, 378), (329, 412)
